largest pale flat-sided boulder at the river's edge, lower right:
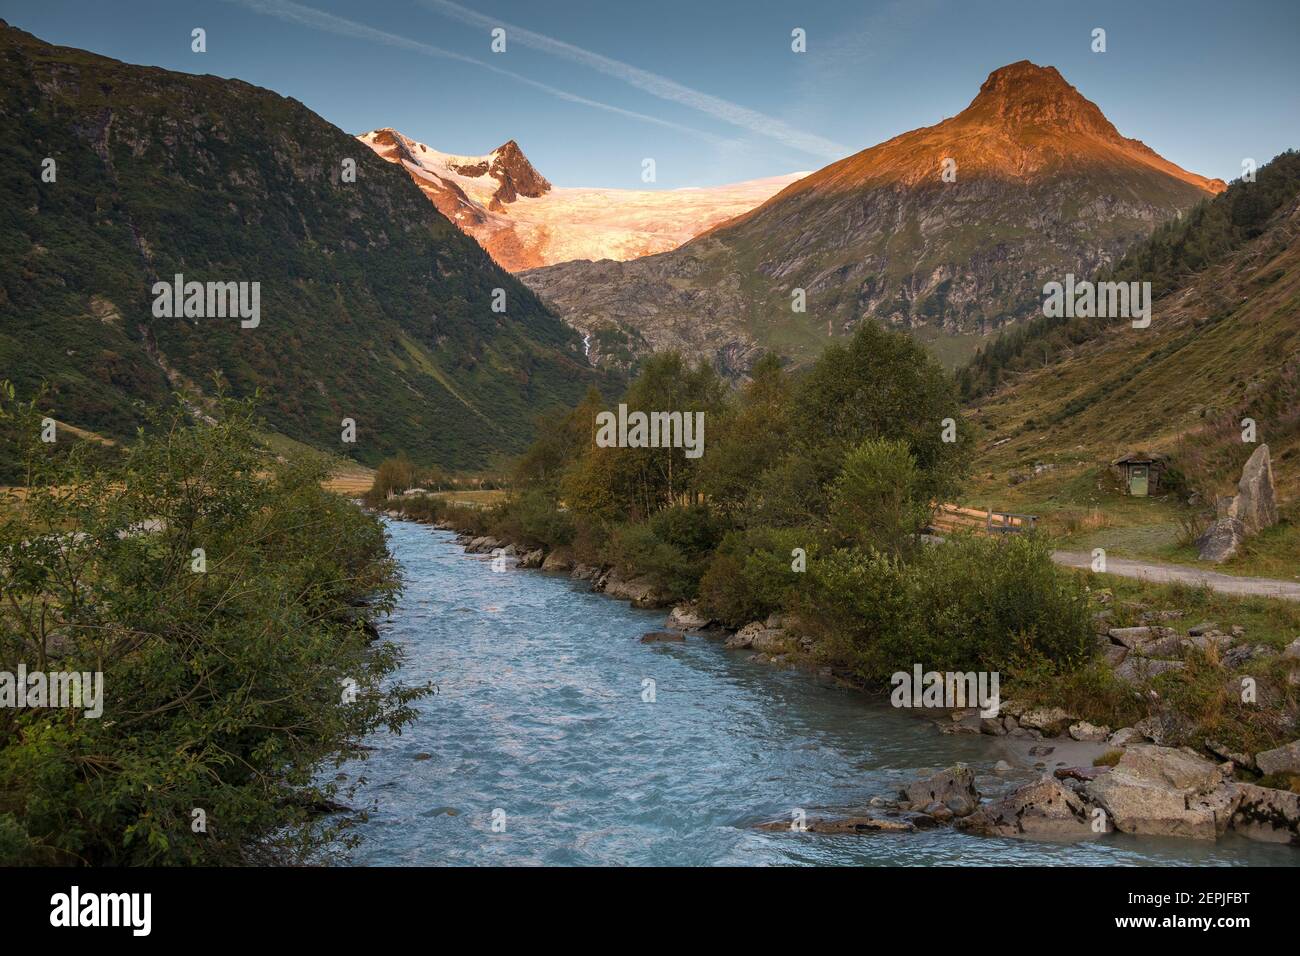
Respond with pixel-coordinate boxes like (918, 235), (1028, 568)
(1086, 744), (1239, 840)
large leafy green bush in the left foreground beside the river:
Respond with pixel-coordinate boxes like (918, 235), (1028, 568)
(0, 392), (423, 865)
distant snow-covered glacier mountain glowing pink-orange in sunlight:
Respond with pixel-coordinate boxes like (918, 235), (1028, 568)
(358, 129), (805, 272)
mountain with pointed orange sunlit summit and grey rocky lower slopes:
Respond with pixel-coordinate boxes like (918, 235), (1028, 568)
(523, 61), (1225, 373)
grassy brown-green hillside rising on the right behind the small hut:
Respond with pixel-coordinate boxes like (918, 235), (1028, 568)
(962, 151), (1300, 497)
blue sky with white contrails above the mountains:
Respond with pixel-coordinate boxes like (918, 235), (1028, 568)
(0, 0), (1300, 189)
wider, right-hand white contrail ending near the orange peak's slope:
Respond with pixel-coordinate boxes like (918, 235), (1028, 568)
(410, 0), (852, 159)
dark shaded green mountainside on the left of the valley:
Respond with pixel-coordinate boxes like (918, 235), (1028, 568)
(0, 22), (608, 468)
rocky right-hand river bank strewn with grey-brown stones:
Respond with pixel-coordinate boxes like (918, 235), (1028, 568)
(353, 515), (1300, 861)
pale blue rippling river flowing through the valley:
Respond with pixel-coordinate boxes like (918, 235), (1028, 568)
(342, 522), (1300, 866)
